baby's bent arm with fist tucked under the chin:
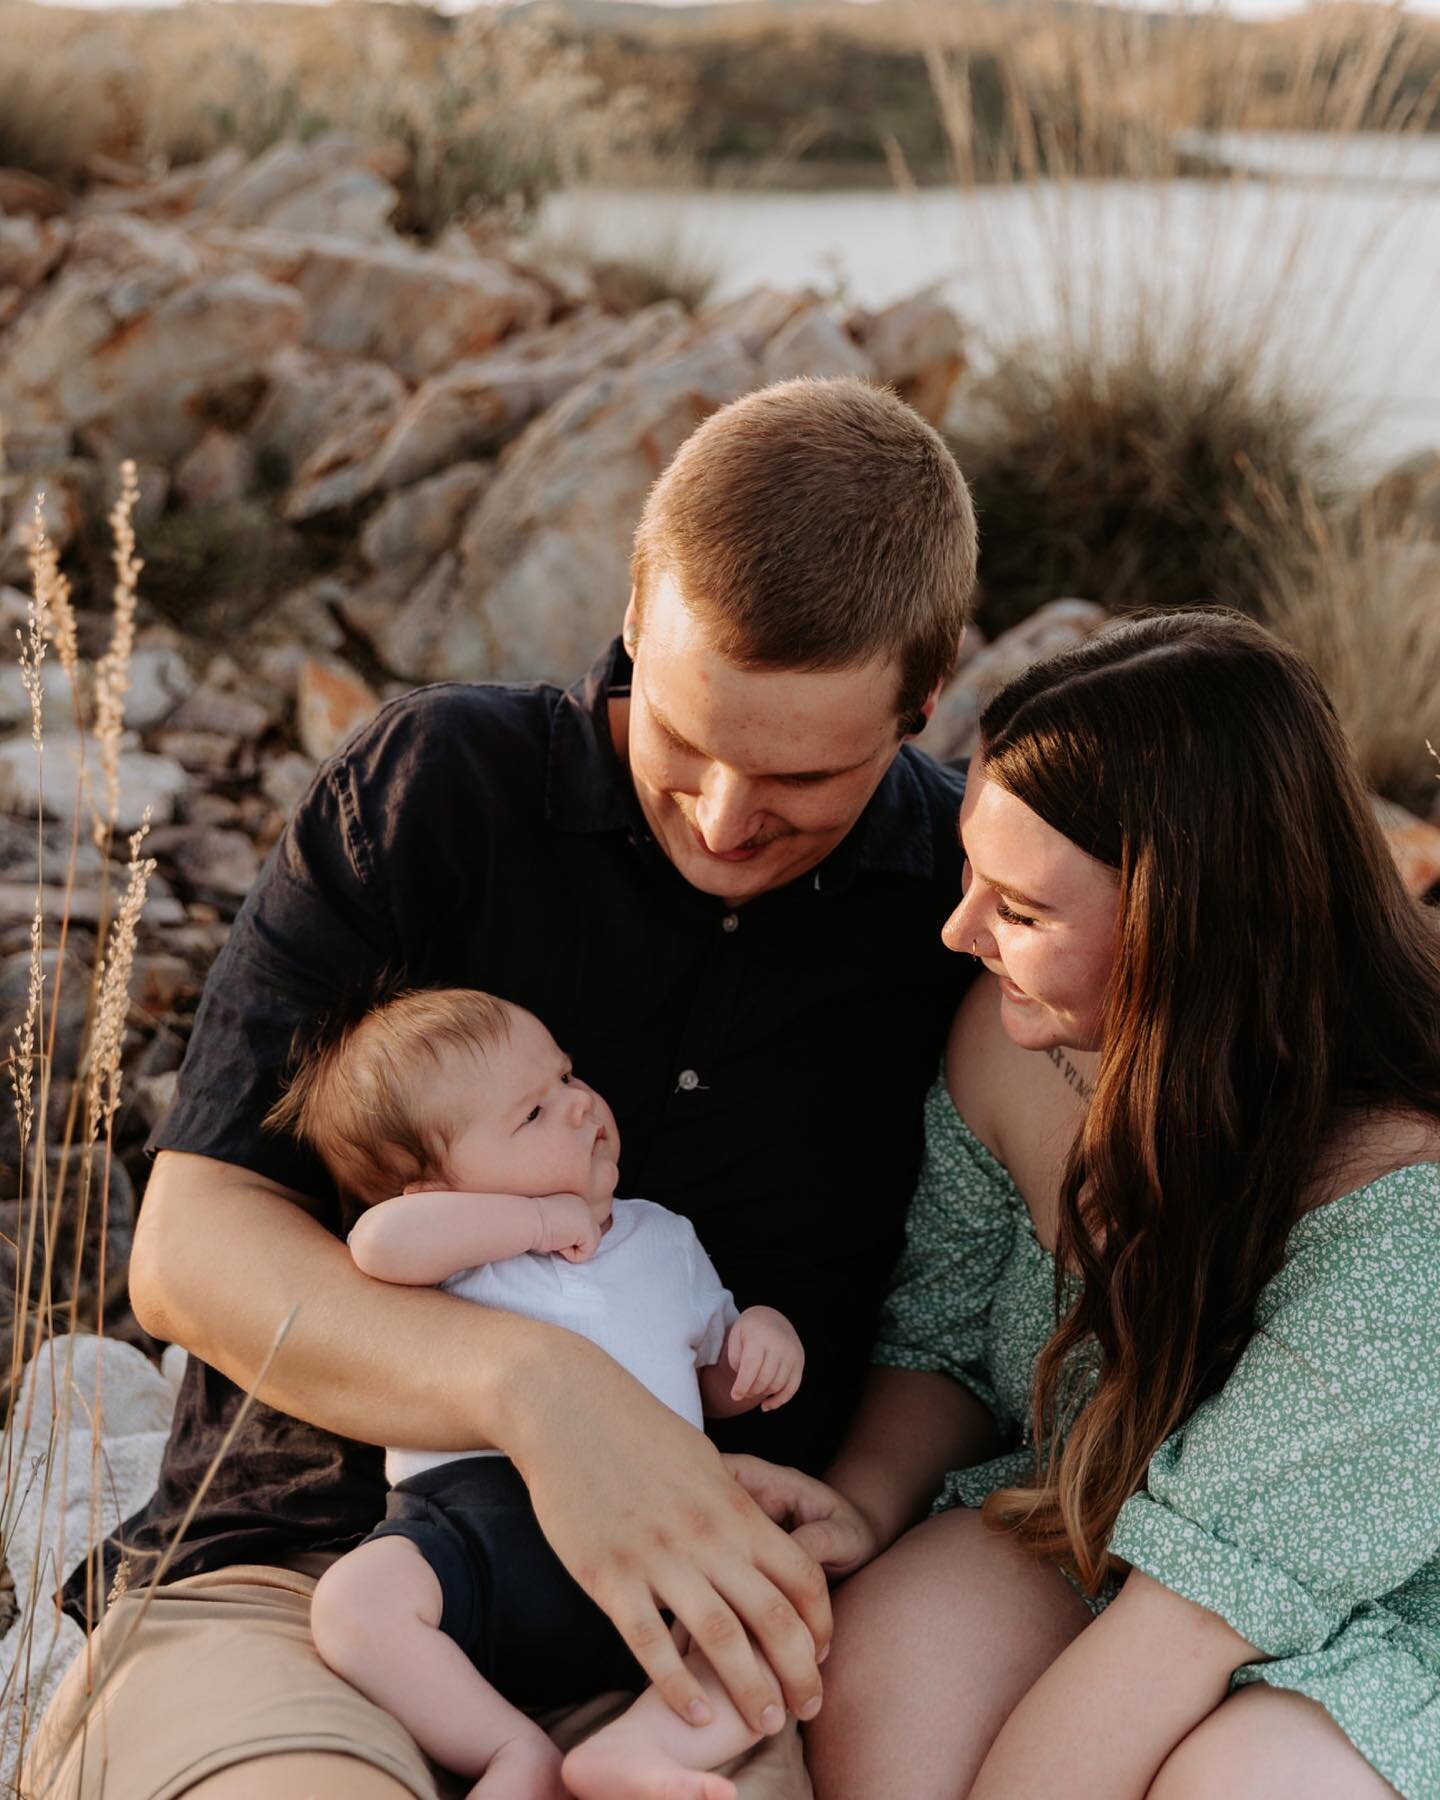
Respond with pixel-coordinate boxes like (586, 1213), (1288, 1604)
(349, 1183), (599, 1287)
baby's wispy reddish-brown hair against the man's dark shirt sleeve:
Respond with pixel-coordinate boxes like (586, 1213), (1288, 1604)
(265, 988), (509, 1206)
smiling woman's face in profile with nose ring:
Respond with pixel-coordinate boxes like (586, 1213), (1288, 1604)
(941, 756), (1120, 1049)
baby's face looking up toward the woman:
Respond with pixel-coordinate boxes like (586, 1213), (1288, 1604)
(427, 1006), (619, 1224)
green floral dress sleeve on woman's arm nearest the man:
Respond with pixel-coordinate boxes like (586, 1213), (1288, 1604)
(871, 1075), (1024, 1418)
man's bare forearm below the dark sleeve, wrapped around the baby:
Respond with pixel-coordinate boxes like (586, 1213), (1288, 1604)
(131, 1152), (583, 1451)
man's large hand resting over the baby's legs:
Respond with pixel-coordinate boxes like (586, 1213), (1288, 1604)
(514, 1341), (832, 1733)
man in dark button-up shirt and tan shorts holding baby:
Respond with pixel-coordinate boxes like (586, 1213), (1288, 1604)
(32, 380), (976, 1800)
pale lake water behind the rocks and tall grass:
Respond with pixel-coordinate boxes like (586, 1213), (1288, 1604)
(540, 133), (1440, 473)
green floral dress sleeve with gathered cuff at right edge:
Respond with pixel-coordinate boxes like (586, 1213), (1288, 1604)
(1111, 1165), (1440, 1656)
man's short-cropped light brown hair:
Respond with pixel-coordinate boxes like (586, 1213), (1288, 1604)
(632, 376), (977, 729)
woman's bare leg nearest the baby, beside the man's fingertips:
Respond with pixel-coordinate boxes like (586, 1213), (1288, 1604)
(806, 1510), (1091, 1800)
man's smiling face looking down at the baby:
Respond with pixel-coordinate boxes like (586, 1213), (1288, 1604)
(626, 574), (900, 905)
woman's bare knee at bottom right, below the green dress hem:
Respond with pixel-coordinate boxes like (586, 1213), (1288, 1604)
(1147, 1685), (1395, 1800)
